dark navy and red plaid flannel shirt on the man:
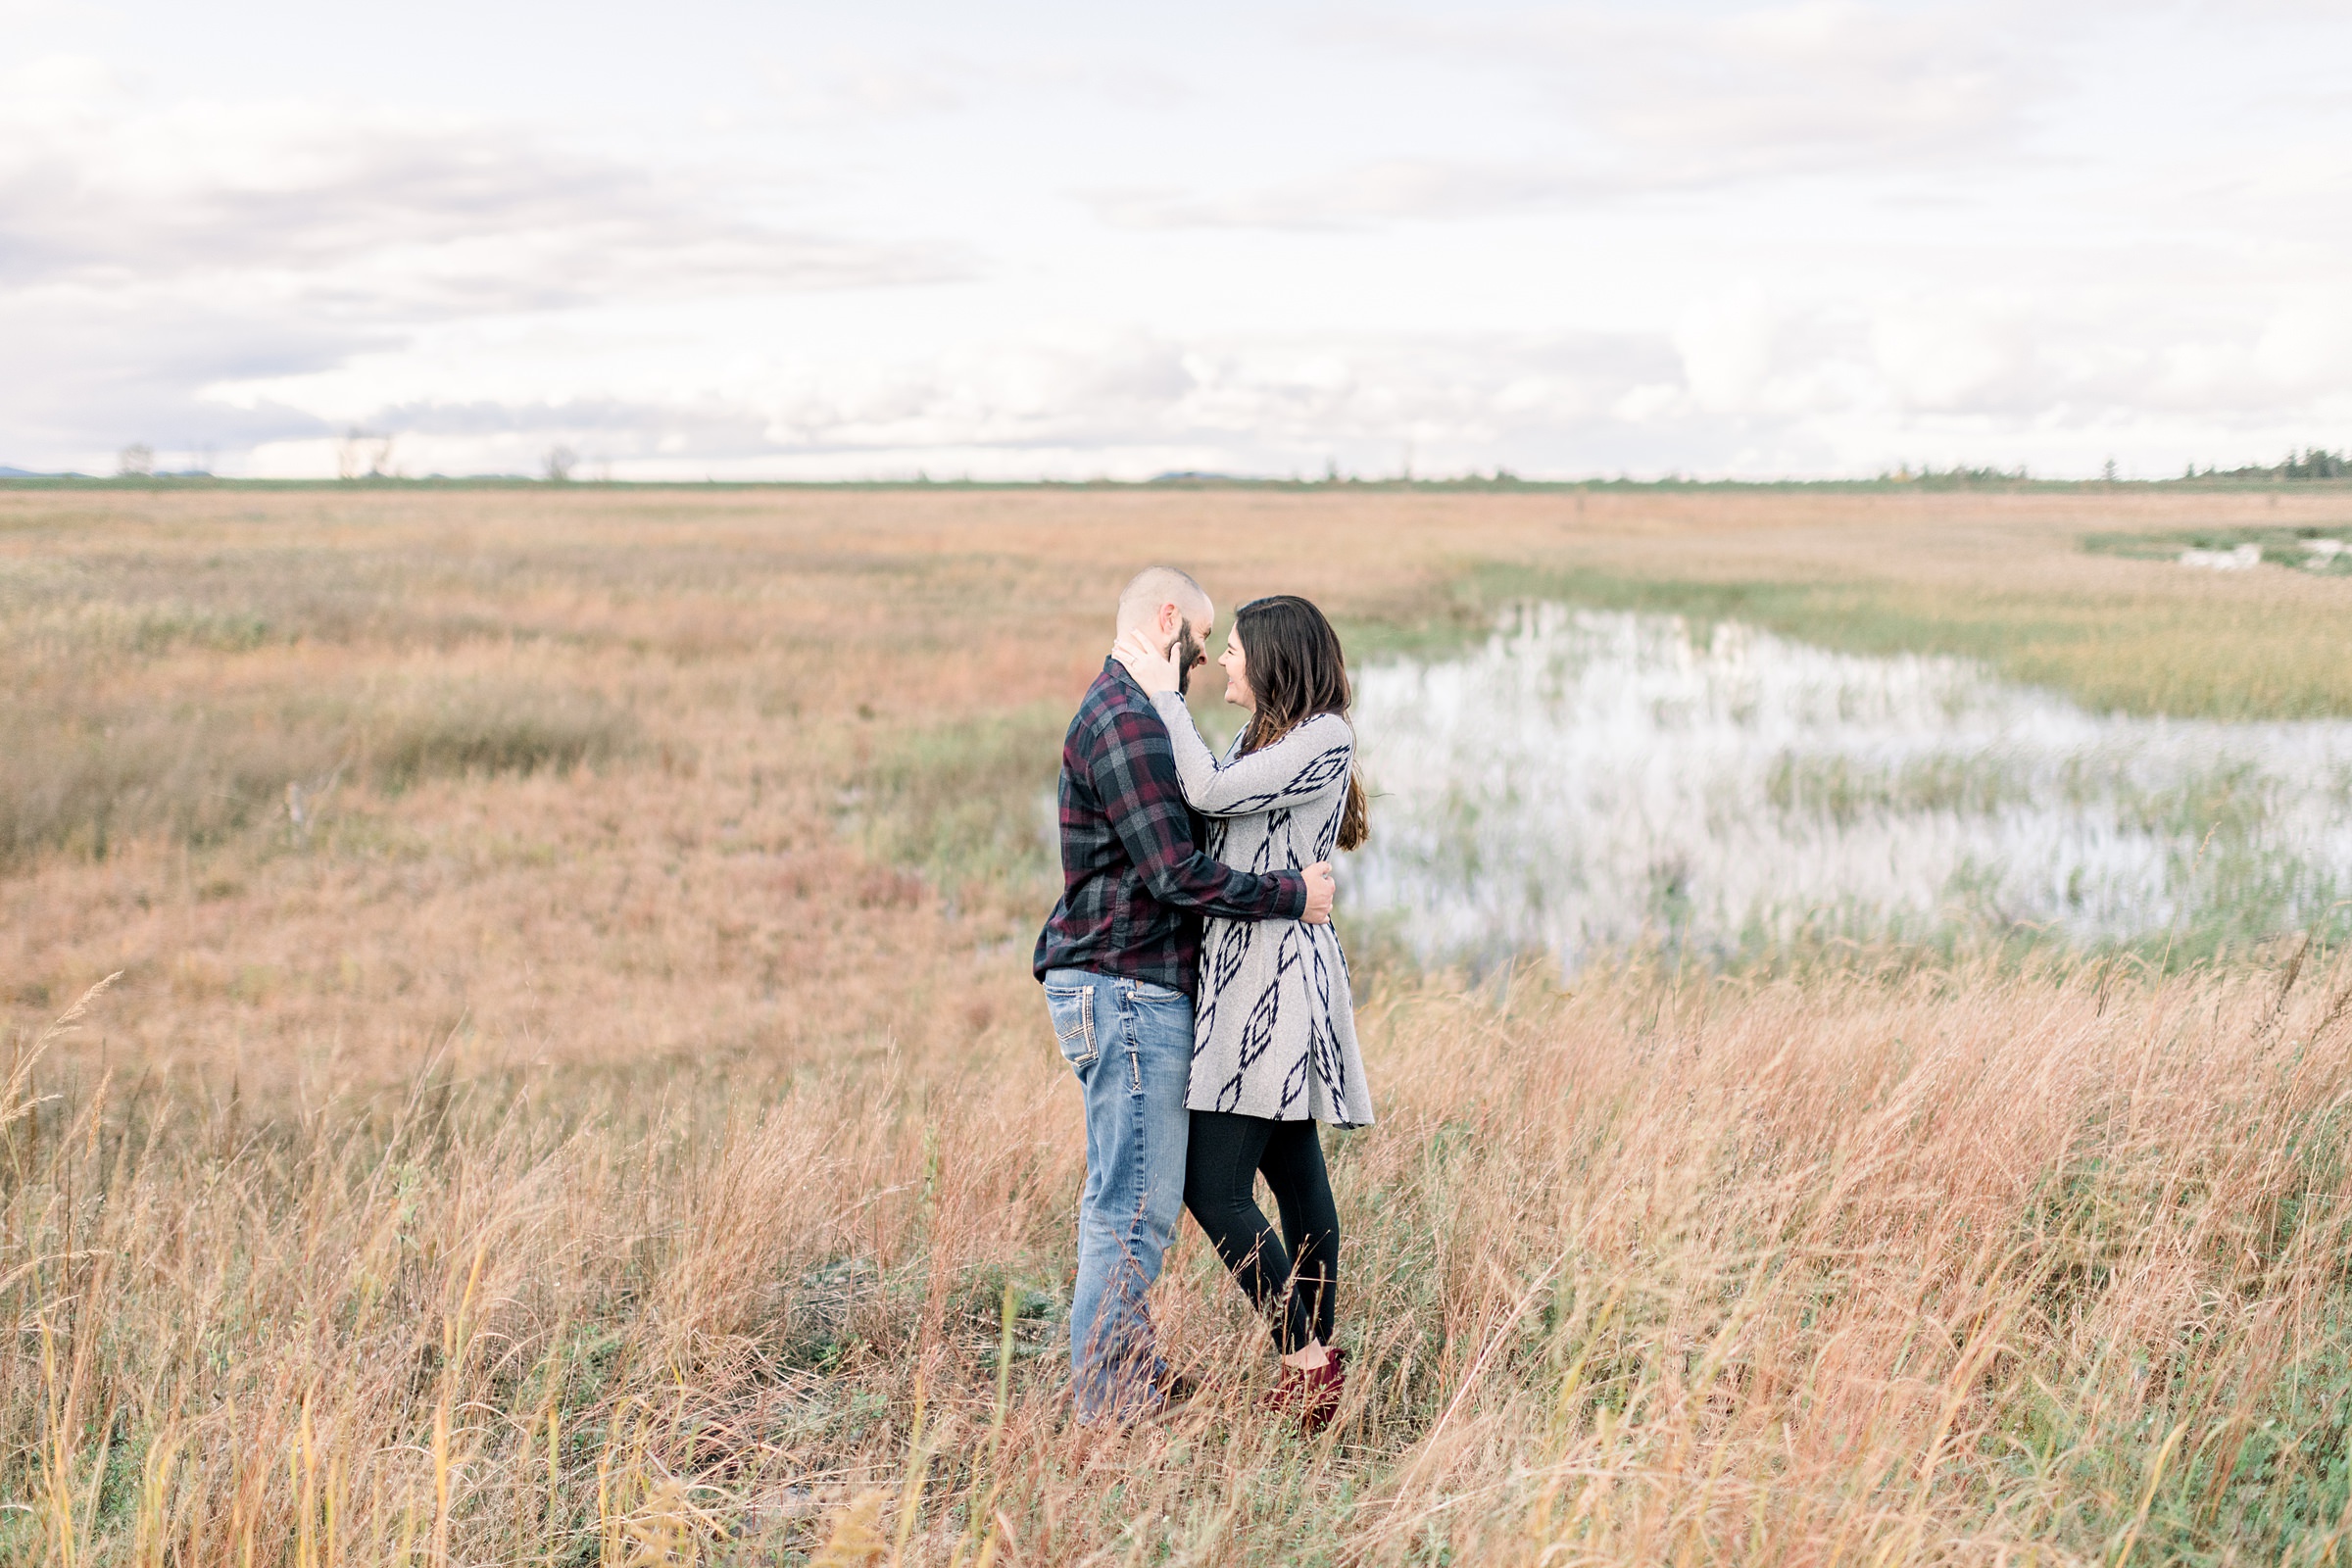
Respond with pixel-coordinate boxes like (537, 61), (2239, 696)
(1037, 659), (1307, 997)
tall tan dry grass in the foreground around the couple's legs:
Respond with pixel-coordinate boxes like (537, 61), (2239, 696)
(0, 964), (2352, 1566)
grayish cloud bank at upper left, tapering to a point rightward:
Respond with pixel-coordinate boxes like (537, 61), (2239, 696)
(0, 61), (969, 305)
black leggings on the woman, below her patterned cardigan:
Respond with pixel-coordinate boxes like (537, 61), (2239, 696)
(1183, 1109), (1339, 1354)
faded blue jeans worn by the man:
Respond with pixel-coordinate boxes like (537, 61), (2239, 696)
(1045, 968), (1193, 1420)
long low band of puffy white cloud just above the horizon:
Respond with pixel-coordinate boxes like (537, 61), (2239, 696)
(91, 284), (2352, 477)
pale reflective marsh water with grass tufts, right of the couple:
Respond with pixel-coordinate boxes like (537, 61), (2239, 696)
(1350, 607), (2352, 968)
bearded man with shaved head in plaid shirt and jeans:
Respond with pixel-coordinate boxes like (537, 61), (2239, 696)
(1035, 566), (1334, 1420)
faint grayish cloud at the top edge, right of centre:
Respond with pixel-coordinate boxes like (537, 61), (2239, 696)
(1082, 0), (2056, 228)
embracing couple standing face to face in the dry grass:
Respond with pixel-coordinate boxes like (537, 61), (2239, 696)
(1037, 566), (1371, 1429)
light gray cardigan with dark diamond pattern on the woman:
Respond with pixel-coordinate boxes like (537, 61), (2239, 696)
(1152, 691), (1371, 1126)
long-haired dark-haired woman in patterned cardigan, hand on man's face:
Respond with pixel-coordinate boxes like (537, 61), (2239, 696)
(1117, 595), (1371, 1432)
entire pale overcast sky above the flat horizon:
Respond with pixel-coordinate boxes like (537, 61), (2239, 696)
(0, 0), (2352, 479)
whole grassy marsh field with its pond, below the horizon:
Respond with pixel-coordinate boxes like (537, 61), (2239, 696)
(14, 484), (2352, 1568)
